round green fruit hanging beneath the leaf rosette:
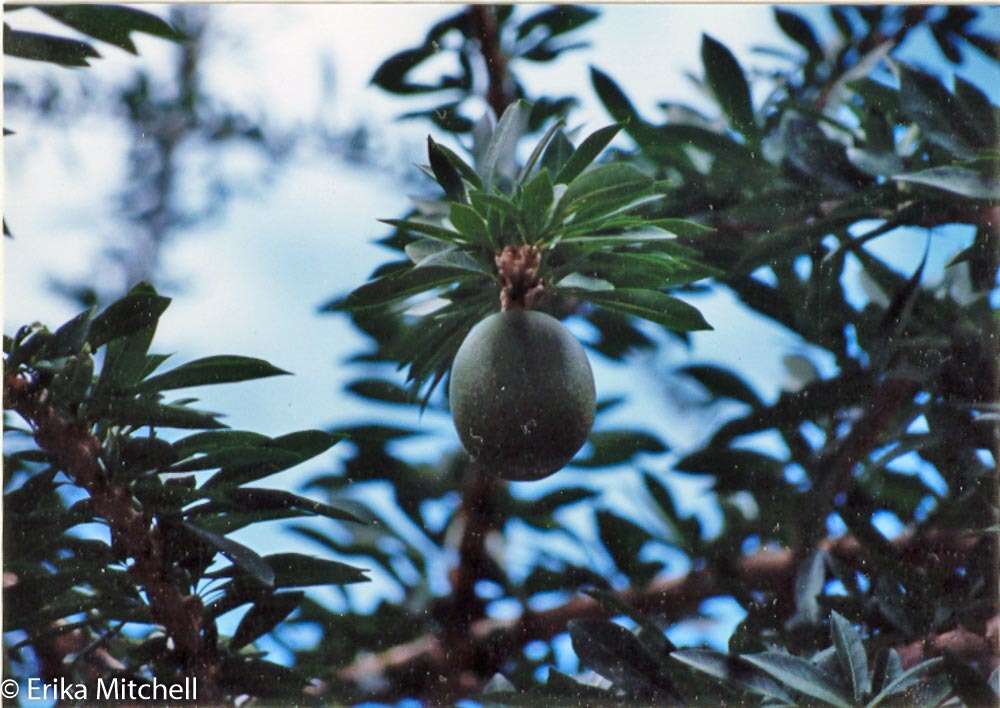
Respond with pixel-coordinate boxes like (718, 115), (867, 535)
(449, 309), (595, 481)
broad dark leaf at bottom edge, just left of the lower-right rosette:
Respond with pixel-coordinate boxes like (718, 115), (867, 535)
(568, 620), (672, 697)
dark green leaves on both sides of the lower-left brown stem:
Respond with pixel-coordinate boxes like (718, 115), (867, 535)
(4, 284), (368, 697)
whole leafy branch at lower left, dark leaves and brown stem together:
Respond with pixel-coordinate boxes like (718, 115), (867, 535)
(3, 285), (370, 701)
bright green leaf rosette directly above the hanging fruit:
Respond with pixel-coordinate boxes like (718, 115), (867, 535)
(327, 101), (716, 403)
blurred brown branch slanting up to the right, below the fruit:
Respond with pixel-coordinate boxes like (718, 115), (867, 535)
(339, 532), (979, 695)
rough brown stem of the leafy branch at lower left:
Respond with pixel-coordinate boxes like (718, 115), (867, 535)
(3, 373), (219, 701)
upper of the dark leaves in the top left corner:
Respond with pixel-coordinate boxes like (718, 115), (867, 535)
(38, 5), (185, 54)
